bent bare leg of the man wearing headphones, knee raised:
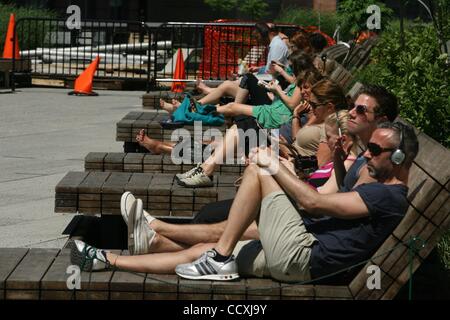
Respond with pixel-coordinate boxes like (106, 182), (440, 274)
(215, 164), (281, 256)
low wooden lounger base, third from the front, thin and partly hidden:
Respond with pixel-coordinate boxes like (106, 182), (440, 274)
(84, 152), (245, 176)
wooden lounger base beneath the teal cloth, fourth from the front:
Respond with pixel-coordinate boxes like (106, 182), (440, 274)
(116, 110), (226, 142)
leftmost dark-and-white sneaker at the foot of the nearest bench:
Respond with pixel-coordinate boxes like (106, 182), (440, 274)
(70, 240), (110, 271)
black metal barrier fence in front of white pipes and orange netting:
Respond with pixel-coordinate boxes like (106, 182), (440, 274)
(12, 18), (298, 90)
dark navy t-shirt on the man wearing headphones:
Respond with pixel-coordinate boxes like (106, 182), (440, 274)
(303, 182), (408, 279)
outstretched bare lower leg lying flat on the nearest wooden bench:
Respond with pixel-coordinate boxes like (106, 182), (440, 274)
(106, 243), (214, 274)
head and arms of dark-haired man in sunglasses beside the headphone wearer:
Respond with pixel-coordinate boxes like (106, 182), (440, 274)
(319, 84), (398, 194)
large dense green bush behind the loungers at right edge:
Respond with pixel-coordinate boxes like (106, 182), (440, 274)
(357, 22), (450, 147)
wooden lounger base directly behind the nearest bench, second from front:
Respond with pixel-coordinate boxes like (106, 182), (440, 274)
(55, 172), (238, 217)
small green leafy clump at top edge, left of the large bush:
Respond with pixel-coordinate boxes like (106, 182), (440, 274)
(338, 0), (393, 39)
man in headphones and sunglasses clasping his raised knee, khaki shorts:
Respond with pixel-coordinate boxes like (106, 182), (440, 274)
(175, 122), (419, 282)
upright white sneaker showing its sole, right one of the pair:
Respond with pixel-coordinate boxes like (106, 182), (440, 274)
(128, 199), (156, 255)
